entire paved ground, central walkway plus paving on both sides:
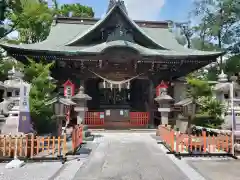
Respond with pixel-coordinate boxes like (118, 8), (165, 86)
(0, 131), (240, 180)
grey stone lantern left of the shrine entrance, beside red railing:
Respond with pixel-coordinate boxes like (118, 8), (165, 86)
(72, 86), (92, 124)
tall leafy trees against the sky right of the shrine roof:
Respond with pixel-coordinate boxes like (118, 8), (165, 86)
(173, 0), (240, 80)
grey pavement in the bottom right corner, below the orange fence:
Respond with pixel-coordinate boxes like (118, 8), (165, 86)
(188, 159), (240, 180)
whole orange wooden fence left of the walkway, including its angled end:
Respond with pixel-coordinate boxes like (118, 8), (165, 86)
(0, 126), (83, 160)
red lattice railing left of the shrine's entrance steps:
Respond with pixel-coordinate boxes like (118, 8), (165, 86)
(84, 112), (104, 126)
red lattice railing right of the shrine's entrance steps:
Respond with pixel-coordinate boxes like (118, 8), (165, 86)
(130, 112), (149, 126)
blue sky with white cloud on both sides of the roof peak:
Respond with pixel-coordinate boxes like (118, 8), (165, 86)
(58, 0), (192, 21)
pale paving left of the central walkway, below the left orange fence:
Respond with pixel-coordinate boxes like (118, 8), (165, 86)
(0, 137), (98, 180)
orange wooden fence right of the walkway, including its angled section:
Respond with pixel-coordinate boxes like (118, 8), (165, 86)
(156, 125), (232, 154)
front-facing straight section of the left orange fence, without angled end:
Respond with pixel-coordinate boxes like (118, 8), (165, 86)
(0, 134), (67, 158)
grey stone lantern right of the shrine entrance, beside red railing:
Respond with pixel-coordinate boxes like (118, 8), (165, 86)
(154, 82), (173, 124)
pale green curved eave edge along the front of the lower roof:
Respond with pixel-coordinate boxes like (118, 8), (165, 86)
(2, 40), (223, 58)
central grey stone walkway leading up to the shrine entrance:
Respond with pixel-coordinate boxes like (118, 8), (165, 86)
(73, 132), (189, 180)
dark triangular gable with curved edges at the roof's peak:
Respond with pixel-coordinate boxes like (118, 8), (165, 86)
(65, 3), (167, 49)
